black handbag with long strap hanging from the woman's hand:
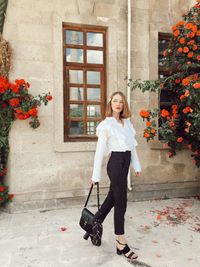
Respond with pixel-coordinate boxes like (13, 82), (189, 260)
(79, 183), (103, 246)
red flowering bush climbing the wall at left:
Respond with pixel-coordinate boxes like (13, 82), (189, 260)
(0, 76), (52, 206)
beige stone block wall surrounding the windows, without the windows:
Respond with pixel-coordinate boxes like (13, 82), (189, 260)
(3, 0), (199, 214)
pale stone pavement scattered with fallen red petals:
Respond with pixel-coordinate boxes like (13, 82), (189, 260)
(0, 198), (200, 267)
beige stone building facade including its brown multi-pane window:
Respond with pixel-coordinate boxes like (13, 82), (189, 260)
(3, 0), (200, 214)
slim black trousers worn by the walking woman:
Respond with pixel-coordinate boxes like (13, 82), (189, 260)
(99, 151), (131, 235)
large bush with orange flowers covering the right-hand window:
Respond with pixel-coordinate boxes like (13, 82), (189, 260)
(130, 0), (200, 167)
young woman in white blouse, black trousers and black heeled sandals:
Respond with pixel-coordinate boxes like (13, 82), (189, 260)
(91, 92), (141, 260)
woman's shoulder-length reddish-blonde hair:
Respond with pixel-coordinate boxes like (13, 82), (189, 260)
(105, 91), (131, 119)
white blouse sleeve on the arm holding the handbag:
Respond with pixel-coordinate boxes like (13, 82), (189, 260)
(92, 129), (107, 182)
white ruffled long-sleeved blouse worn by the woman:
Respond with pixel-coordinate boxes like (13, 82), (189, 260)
(91, 117), (141, 182)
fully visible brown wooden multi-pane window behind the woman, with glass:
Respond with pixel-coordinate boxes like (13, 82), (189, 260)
(63, 24), (106, 141)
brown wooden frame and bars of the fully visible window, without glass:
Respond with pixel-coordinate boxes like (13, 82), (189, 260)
(63, 23), (107, 142)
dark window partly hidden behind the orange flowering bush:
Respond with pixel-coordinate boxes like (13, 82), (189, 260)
(158, 33), (173, 139)
